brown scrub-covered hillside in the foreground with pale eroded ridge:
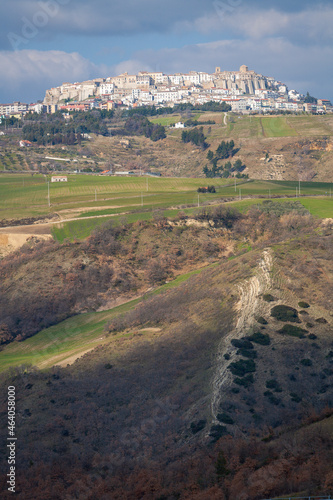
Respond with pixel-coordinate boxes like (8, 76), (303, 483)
(0, 204), (333, 500)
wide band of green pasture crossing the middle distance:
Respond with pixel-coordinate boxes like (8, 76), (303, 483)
(0, 174), (333, 229)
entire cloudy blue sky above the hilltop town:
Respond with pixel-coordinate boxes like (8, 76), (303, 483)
(0, 0), (333, 102)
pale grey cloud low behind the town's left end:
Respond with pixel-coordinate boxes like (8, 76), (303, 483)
(0, 50), (111, 102)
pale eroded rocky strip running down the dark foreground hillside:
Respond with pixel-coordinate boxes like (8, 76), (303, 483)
(211, 249), (273, 422)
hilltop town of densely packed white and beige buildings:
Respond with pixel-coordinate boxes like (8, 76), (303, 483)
(0, 65), (333, 117)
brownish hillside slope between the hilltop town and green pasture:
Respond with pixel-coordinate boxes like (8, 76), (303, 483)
(0, 110), (333, 182)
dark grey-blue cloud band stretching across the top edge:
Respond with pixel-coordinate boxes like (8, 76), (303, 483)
(0, 0), (333, 50)
